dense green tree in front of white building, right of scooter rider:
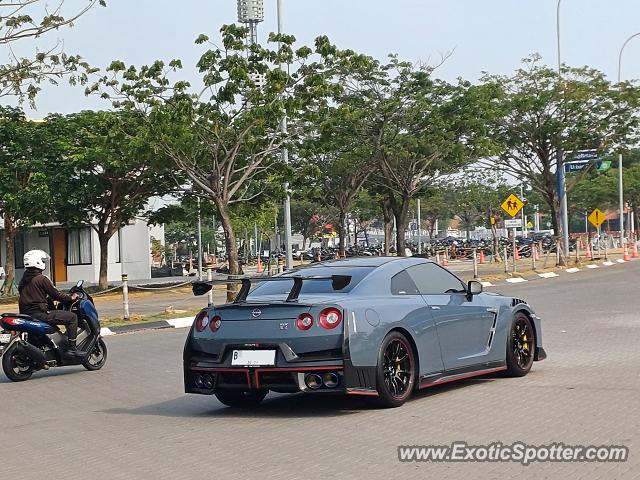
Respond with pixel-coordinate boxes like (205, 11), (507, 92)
(47, 111), (176, 288)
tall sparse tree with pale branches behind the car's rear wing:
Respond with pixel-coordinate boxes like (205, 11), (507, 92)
(97, 25), (326, 298)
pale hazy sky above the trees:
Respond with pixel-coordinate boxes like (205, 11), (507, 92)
(8, 0), (640, 118)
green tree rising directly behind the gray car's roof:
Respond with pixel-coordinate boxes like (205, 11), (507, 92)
(324, 52), (496, 255)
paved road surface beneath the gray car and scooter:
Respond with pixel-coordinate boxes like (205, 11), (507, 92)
(0, 262), (640, 479)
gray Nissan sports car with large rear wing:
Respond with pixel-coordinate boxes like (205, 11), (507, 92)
(184, 257), (546, 407)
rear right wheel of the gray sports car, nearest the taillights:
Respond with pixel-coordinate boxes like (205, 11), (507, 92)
(376, 332), (416, 408)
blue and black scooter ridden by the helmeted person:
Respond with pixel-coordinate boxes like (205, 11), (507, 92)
(0, 280), (107, 382)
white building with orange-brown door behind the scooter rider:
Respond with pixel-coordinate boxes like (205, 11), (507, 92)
(0, 219), (155, 283)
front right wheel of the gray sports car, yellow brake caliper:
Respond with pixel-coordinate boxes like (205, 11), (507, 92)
(506, 312), (536, 377)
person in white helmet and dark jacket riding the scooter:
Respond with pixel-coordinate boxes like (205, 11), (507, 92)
(18, 250), (82, 357)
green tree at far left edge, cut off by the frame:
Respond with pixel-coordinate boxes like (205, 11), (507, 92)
(0, 107), (57, 293)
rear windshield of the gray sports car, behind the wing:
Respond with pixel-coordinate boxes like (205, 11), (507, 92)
(249, 267), (375, 298)
